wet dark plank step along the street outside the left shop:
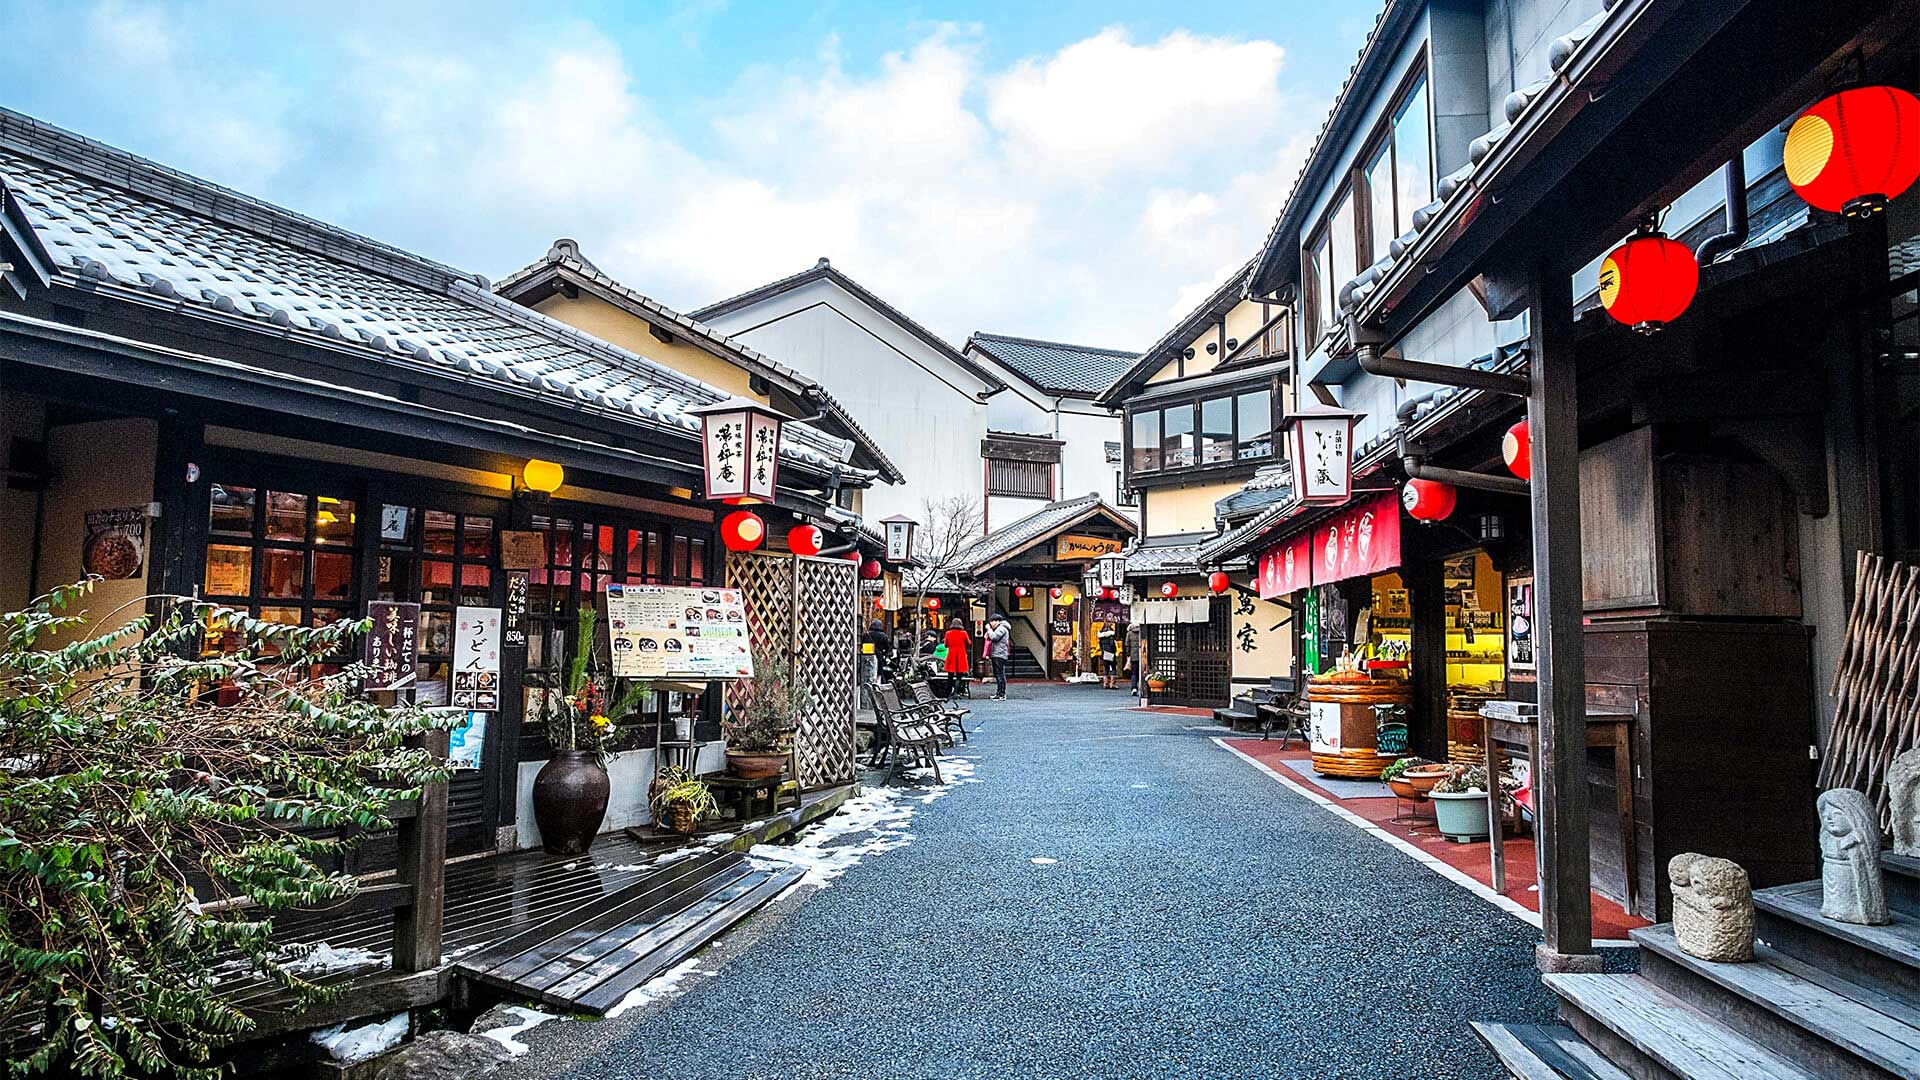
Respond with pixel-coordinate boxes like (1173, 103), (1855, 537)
(453, 851), (803, 1013)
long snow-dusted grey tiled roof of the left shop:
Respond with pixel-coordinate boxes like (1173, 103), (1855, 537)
(0, 110), (852, 469)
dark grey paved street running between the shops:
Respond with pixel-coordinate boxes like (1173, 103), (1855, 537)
(513, 686), (1574, 1080)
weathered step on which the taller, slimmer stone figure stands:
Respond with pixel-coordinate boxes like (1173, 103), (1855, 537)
(1753, 882), (1920, 997)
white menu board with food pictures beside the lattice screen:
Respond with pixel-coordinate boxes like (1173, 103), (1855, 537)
(605, 584), (753, 678)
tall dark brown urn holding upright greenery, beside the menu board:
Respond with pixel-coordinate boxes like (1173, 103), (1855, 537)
(534, 607), (647, 855)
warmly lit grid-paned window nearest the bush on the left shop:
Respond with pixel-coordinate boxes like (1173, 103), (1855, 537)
(200, 482), (359, 653)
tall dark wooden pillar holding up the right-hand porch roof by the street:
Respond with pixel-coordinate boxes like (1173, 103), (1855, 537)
(1526, 267), (1599, 970)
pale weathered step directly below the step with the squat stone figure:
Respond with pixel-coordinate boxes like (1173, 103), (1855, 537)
(1542, 974), (1826, 1080)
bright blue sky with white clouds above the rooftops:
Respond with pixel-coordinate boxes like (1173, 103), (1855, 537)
(0, 0), (1379, 350)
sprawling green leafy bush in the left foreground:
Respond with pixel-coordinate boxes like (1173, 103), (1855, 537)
(0, 580), (445, 1078)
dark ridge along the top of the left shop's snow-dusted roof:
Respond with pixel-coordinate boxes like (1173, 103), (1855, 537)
(0, 106), (486, 292)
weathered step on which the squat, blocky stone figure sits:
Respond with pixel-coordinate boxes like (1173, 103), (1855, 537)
(1632, 924), (1920, 1080)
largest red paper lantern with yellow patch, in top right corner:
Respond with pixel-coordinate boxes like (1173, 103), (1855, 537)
(1782, 86), (1920, 217)
